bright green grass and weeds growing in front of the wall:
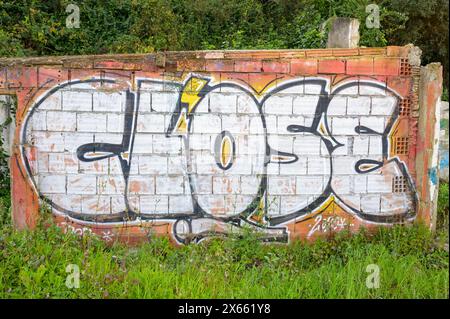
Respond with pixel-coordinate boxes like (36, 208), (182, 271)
(0, 185), (449, 298)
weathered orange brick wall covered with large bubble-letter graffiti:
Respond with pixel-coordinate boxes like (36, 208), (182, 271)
(0, 47), (442, 243)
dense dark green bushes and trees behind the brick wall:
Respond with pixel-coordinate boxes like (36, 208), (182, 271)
(0, 0), (449, 87)
